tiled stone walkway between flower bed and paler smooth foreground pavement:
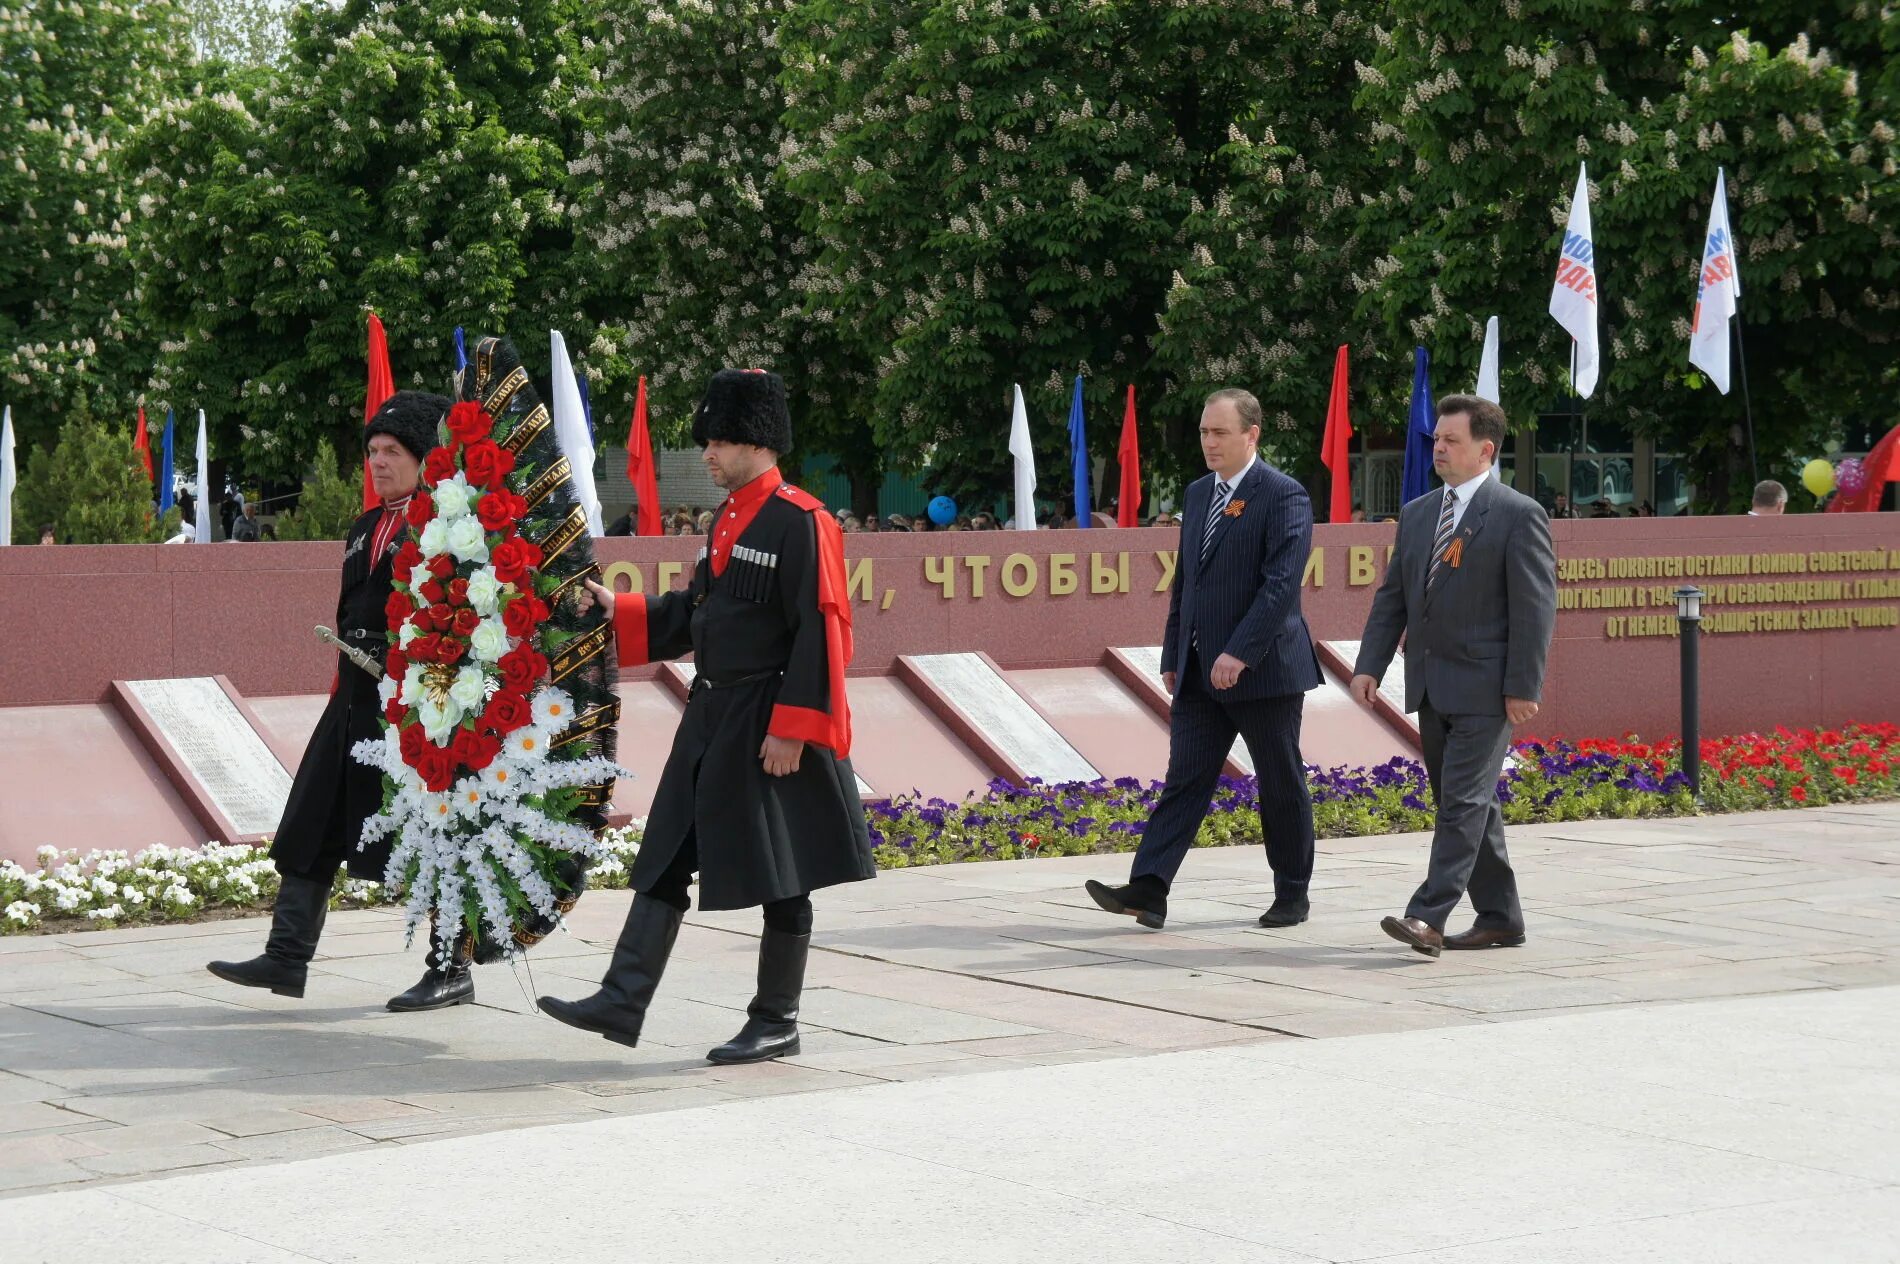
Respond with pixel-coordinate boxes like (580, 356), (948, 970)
(0, 804), (1900, 1196)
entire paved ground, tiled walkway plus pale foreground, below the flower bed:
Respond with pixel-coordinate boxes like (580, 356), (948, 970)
(0, 806), (1900, 1262)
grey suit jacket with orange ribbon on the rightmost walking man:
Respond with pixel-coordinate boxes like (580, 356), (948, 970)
(1353, 471), (1556, 715)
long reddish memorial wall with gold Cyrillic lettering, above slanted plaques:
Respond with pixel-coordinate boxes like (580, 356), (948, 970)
(0, 513), (1900, 736)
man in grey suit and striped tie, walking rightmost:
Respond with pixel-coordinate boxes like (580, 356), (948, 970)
(1351, 395), (1556, 956)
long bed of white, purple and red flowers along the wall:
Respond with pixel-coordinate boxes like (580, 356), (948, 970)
(0, 724), (1900, 933)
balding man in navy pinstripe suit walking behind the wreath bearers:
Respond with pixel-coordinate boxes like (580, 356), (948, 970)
(1087, 390), (1321, 929)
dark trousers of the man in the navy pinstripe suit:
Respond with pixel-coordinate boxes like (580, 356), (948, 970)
(1132, 656), (1313, 899)
